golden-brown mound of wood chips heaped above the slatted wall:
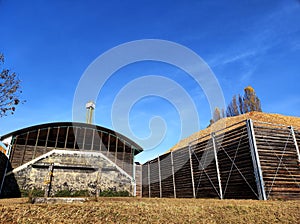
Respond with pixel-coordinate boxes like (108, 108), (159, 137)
(168, 111), (300, 152)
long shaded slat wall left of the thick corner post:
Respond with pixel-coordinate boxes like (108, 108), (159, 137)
(142, 123), (258, 199)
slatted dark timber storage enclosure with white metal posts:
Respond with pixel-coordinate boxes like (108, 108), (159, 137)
(142, 119), (300, 200)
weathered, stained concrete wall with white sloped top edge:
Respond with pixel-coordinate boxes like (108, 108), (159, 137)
(12, 150), (133, 196)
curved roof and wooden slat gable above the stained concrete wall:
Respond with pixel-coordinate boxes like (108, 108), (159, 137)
(0, 122), (143, 176)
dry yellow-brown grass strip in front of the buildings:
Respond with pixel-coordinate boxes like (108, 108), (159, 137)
(0, 198), (300, 224)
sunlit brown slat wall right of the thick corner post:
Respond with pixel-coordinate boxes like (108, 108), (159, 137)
(254, 124), (300, 199)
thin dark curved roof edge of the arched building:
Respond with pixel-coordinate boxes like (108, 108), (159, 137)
(0, 122), (143, 155)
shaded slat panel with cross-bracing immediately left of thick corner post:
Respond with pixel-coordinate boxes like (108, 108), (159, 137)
(216, 125), (258, 199)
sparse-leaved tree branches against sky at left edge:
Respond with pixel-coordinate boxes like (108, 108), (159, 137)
(0, 53), (24, 117)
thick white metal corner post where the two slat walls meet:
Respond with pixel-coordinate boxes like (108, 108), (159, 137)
(246, 119), (267, 200)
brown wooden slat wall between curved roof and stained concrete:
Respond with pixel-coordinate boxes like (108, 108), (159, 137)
(10, 127), (133, 176)
